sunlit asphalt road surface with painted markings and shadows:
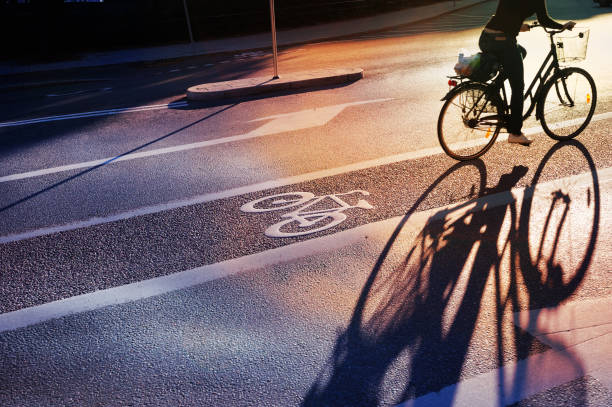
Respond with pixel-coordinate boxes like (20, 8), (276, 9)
(0, 0), (612, 406)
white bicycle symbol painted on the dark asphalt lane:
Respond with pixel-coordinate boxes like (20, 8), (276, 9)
(240, 190), (374, 237)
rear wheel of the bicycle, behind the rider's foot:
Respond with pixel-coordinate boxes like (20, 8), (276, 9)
(438, 83), (503, 161)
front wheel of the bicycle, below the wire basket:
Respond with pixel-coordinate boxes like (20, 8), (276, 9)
(538, 67), (597, 140)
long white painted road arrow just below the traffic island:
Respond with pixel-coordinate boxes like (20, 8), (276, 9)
(0, 99), (391, 183)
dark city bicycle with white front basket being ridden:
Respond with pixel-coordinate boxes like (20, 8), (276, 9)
(438, 22), (597, 161)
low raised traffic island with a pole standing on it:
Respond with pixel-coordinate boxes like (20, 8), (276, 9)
(187, 68), (363, 101)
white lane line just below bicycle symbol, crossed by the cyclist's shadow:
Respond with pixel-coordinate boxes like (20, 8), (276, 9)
(0, 168), (612, 334)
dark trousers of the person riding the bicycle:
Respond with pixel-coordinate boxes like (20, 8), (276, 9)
(478, 31), (527, 134)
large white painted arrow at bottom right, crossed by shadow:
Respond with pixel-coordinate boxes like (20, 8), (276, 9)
(396, 298), (612, 407)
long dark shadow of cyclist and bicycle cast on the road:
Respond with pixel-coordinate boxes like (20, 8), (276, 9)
(303, 141), (600, 406)
